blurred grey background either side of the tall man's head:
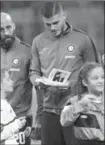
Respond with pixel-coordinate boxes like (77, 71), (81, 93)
(1, 1), (104, 54)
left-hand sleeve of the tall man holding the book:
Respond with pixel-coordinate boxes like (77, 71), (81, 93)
(29, 38), (41, 85)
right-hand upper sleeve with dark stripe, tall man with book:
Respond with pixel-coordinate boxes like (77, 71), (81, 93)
(82, 36), (101, 63)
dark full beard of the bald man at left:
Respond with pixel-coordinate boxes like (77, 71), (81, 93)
(0, 35), (15, 51)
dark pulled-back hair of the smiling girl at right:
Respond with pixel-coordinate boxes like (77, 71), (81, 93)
(76, 62), (103, 99)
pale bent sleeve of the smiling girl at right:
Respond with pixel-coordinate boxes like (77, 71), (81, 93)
(60, 103), (84, 126)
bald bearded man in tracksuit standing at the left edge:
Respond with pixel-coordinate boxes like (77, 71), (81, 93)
(0, 13), (32, 144)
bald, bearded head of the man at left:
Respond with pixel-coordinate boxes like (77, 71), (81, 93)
(0, 12), (15, 50)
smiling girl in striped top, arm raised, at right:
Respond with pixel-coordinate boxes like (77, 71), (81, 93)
(60, 62), (105, 145)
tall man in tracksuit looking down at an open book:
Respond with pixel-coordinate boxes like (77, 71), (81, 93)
(30, 2), (99, 145)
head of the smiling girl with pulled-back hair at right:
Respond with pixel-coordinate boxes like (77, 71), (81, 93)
(77, 62), (104, 99)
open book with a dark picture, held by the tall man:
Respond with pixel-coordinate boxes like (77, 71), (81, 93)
(36, 68), (71, 88)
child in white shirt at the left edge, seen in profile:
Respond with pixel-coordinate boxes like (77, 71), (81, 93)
(0, 72), (26, 144)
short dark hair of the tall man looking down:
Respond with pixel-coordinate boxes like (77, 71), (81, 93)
(41, 2), (64, 18)
